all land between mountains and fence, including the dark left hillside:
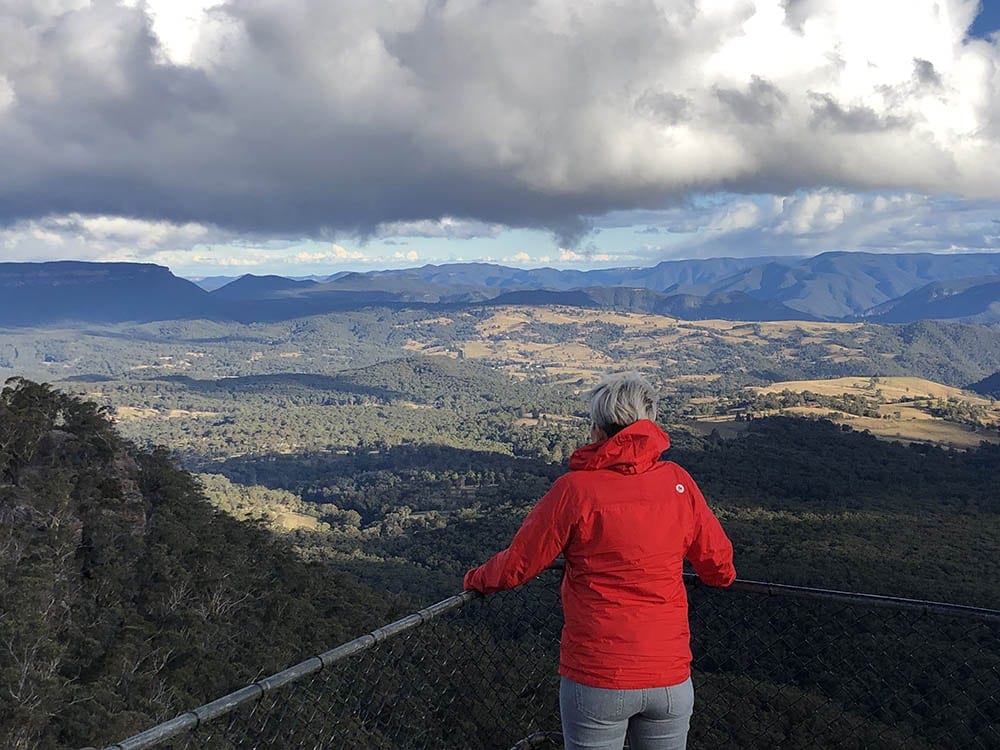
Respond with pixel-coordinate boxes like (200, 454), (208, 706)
(0, 268), (1000, 746)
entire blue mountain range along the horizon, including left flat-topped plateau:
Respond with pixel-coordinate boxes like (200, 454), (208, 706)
(0, 252), (1000, 326)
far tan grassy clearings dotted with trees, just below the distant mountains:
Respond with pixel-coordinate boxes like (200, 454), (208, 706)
(405, 307), (928, 383)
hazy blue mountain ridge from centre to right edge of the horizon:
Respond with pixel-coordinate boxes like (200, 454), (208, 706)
(229, 252), (1000, 323)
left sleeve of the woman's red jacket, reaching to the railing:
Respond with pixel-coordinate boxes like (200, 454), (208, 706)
(463, 480), (572, 594)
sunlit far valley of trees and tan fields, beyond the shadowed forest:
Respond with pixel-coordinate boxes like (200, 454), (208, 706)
(0, 306), (1000, 458)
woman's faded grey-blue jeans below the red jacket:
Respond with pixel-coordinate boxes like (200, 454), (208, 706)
(559, 677), (694, 750)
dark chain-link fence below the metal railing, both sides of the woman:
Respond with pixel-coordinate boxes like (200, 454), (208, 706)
(101, 570), (1000, 750)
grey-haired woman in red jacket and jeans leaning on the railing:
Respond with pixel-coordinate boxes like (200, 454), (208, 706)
(465, 374), (736, 750)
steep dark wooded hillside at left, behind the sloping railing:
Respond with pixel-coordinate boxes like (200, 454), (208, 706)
(0, 381), (395, 748)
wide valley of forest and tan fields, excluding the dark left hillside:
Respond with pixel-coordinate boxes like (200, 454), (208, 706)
(5, 305), (1000, 603)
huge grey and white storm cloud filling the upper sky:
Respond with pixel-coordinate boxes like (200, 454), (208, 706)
(0, 0), (1000, 244)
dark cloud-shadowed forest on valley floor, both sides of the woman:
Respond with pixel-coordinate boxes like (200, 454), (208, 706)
(213, 418), (1000, 607)
